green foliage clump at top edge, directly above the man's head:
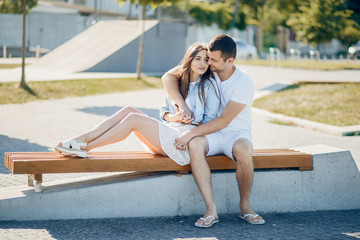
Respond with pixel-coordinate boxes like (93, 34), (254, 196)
(189, 1), (246, 30)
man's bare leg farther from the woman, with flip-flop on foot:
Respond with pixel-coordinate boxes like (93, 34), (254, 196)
(233, 138), (262, 222)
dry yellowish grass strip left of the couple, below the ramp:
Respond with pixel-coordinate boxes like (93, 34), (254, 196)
(0, 77), (163, 104)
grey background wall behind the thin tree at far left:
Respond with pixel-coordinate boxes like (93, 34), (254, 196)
(0, 12), (93, 57)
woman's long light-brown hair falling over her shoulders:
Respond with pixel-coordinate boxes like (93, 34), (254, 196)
(174, 43), (219, 104)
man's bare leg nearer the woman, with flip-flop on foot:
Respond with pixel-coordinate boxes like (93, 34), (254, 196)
(189, 137), (218, 225)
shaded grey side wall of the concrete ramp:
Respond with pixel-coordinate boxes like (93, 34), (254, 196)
(86, 23), (186, 74)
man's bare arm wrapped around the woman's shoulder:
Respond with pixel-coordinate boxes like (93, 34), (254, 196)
(161, 67), (192, 119)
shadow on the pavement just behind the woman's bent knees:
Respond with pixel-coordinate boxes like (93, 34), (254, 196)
(78, 106), (159, 120)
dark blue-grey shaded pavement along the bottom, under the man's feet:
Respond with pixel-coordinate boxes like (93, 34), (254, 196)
(0, 210), (360, 240)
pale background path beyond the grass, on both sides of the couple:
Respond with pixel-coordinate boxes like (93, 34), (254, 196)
(0, 58), (360, 84)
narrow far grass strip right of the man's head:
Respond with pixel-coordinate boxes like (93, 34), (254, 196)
(236, 59), (360, 70)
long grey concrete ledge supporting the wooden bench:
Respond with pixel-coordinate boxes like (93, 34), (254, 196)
(0, 145), (360, 221)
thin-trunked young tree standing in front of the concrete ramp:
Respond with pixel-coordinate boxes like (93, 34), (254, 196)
(116, 0), (177, 79)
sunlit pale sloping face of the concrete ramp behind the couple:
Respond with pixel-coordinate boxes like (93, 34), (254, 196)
(29, 20), (158, 72)
